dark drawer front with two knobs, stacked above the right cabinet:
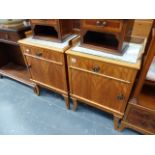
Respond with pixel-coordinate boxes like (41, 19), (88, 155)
(82, 19), (123, 32)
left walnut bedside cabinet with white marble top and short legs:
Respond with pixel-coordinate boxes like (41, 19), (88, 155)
(19, 35), (78, 108)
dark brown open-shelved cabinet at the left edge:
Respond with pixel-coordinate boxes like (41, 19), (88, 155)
(0, 25), (36, 90)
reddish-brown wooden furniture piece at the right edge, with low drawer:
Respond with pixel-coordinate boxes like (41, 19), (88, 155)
(120, 27), (155, 134)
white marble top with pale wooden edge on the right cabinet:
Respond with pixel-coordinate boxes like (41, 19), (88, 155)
(66, 38), (146, 70)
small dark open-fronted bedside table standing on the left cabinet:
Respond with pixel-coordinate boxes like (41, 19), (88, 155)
(31, 19), (73, 42)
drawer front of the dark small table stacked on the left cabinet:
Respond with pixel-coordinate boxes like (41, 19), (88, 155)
(31, 19), (57, 25)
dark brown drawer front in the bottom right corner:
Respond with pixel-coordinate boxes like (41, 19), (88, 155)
(126, 106), (155, 134)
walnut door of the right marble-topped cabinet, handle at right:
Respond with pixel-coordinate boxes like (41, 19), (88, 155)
(70, 68), (130, 112)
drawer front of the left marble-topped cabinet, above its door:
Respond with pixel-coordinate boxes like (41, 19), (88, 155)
(22, 45), (63, 62)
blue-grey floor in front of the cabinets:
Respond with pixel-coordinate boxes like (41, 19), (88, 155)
(0, 77), (138, 135)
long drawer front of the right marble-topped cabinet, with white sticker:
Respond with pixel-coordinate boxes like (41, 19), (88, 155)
(69, 56), (137, 83)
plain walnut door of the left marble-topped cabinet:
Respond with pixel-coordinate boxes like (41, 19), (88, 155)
(26, 56), (67, 90)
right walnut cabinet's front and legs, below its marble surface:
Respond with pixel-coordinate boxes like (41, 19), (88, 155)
(66, 50), (140, 129)
